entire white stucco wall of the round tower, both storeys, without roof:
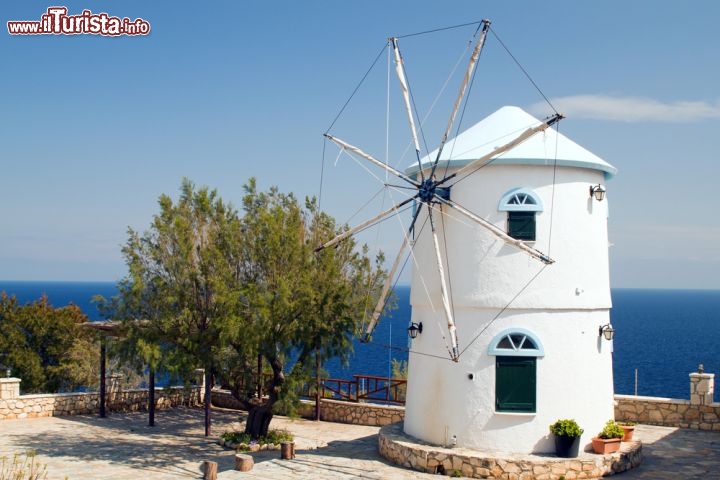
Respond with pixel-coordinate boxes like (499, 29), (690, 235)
(405, 165), (614, 453)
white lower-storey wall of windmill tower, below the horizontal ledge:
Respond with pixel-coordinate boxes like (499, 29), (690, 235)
(405, 308), (614, 453)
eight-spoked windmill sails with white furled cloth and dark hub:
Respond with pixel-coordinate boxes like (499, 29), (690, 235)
(316, 20), (563, 362)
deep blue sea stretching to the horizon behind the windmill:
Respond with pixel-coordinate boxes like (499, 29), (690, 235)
(0, 281), (720, 399)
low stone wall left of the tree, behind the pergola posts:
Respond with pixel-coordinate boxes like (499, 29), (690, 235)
(0, 387), (202, 420)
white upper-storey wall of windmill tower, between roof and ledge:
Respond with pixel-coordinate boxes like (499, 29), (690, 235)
(411, 165), (611, 308)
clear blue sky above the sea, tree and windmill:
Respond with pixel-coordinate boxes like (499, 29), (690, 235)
(0, 0), (720, 289)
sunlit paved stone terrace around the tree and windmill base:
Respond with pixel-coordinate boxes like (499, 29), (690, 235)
(0, 408), (720, 480)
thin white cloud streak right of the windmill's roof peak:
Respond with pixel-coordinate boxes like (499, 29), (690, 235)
(529, 95), (720, 123)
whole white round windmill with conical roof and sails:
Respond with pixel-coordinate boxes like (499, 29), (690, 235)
(319, 21), (615, 453)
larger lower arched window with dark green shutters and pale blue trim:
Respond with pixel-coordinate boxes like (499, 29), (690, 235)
(488, 328), (545, 413)
